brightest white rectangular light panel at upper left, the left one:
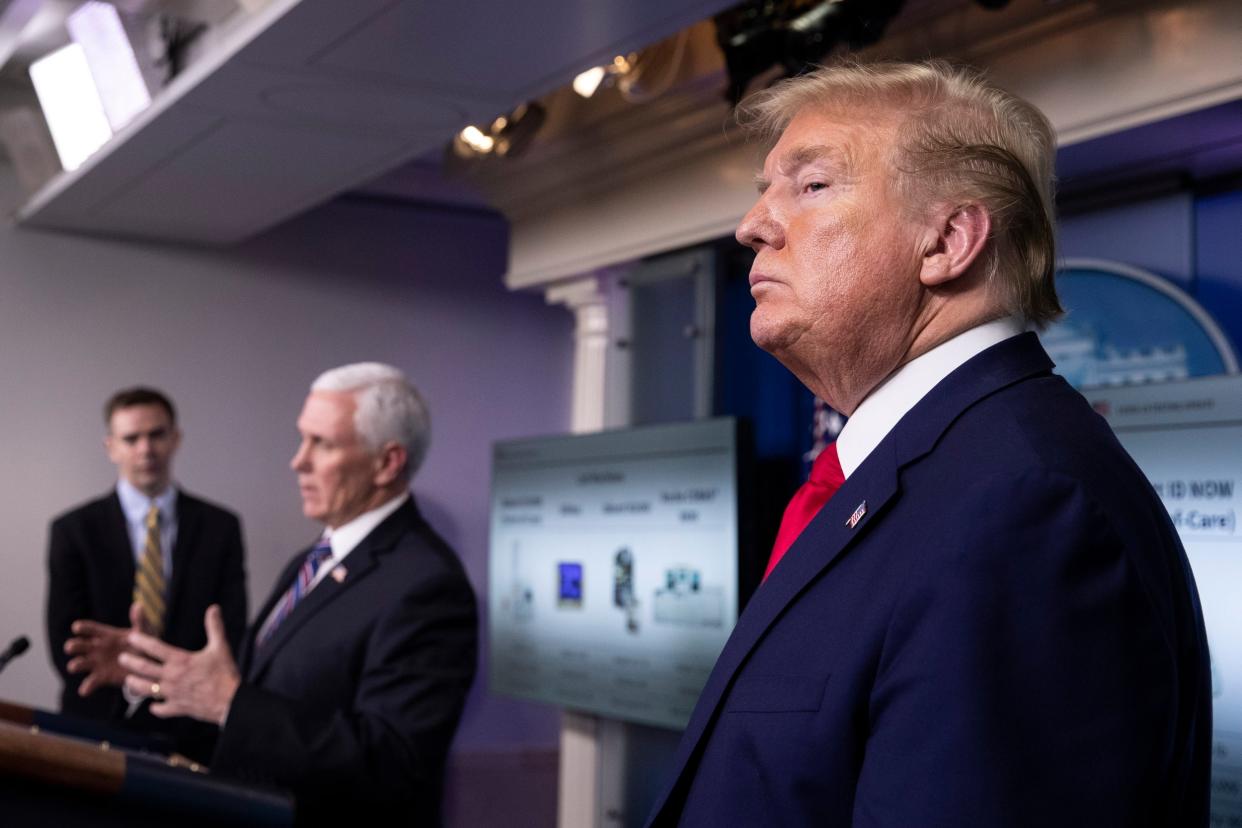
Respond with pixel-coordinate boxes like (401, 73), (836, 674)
(30, 43), (112, 170)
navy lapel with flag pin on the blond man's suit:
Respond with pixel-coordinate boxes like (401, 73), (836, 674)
(655, 333), (1052, 814)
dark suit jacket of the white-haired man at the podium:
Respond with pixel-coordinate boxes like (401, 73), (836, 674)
(211, 498), (478, 826)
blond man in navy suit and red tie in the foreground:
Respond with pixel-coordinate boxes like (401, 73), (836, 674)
(651, 62), (1211, 828)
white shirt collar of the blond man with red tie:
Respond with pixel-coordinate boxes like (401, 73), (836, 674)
(837, 317), (1025, 478)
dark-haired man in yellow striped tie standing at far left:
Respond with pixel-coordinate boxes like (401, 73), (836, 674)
(47, 387), (246, 757)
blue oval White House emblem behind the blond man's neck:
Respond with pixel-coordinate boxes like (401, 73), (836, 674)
(1040, 259), (1238, 389)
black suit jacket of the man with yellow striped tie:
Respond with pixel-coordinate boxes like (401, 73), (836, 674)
(47, 490), (246, 758)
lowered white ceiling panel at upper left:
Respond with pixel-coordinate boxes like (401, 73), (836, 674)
(17, 0), (732, 243)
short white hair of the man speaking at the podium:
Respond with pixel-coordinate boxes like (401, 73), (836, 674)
(311, 362), (431, 479)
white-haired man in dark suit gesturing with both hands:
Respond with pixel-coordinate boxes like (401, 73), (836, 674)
(120, 362), (477, 826)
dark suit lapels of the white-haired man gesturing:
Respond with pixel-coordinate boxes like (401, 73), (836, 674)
(246, 499), (419, 680)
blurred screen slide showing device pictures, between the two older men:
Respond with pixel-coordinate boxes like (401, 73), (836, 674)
(488, 420), (738, 729)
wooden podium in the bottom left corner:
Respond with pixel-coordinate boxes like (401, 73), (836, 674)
(0, 701), (293, 828)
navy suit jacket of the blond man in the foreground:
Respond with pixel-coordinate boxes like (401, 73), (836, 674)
(651, 334), (1211, 828)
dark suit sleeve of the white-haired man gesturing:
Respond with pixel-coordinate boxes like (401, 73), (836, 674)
(212, 574), (477, 803)
